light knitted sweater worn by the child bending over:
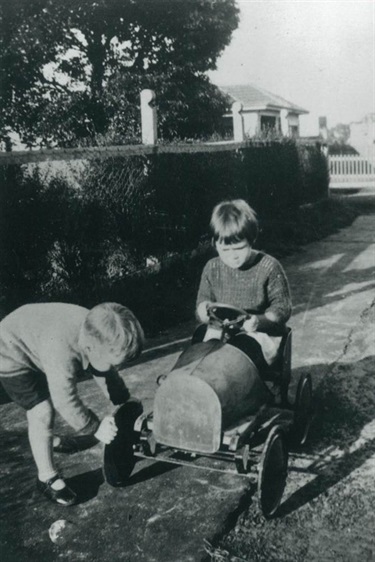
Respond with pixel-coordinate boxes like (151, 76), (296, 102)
(0, 303), (105, 434)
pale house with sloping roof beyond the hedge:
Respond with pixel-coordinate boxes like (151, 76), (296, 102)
(220, 84), (309, 137)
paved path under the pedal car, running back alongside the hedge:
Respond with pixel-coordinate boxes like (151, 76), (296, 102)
(0, 196), (375, 562)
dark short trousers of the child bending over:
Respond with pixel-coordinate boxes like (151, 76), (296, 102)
(0, 371), (50, 410)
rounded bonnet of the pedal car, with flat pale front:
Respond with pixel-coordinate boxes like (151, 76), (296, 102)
(153, 339), (272, 453)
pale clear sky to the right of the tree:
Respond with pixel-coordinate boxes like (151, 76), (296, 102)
(209, 0), (375, 135)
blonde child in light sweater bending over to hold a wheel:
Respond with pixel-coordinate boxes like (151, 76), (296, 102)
(0, 303), (144, 505)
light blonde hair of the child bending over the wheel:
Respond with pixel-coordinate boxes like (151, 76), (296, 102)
(81, 302), (144, 362)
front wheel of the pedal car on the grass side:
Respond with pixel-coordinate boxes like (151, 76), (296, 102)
(258, 425), (288, 518)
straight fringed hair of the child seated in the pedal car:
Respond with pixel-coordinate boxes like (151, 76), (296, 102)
(210, 199), (258, 245)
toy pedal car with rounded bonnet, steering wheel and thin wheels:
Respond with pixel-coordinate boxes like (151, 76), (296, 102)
(103, 304), (312, 517)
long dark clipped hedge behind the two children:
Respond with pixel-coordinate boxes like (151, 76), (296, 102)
(0, 140), (328, 329)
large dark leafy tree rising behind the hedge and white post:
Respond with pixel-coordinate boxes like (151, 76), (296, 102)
(0, 0), (238, 145)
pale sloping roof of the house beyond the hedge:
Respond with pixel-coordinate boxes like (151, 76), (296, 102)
(220, 84), (309, 115)
